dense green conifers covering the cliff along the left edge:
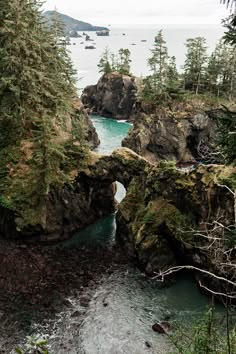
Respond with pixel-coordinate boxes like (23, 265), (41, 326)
(0, 0), (86, 228)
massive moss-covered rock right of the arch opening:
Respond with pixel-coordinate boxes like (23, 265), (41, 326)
(117, 158), (236, 296)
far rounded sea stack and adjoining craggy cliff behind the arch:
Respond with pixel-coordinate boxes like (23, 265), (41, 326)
(82, 73), (220, 163)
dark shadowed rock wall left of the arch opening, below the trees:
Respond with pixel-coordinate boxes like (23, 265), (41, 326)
(0, 175), (116, 241)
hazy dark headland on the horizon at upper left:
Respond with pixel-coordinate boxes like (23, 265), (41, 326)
(43, 11), (109, 35)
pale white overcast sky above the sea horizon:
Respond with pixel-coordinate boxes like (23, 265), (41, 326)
(43, 0), (228, 26)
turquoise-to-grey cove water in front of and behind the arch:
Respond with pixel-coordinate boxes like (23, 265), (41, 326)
(48, 116), (221, 354)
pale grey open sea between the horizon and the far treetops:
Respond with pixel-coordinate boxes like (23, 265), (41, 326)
(68, 25), (224, 92)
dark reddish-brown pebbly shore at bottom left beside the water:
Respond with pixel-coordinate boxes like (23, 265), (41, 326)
(0, 235), (127, 354)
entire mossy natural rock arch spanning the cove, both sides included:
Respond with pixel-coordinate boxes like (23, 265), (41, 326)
(0, 148), (236, 298)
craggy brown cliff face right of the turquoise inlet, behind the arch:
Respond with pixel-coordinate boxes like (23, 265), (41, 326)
(122, 111), (215, 163)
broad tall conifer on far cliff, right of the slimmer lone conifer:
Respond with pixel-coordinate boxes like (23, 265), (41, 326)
(184, 37), (207, 94)
